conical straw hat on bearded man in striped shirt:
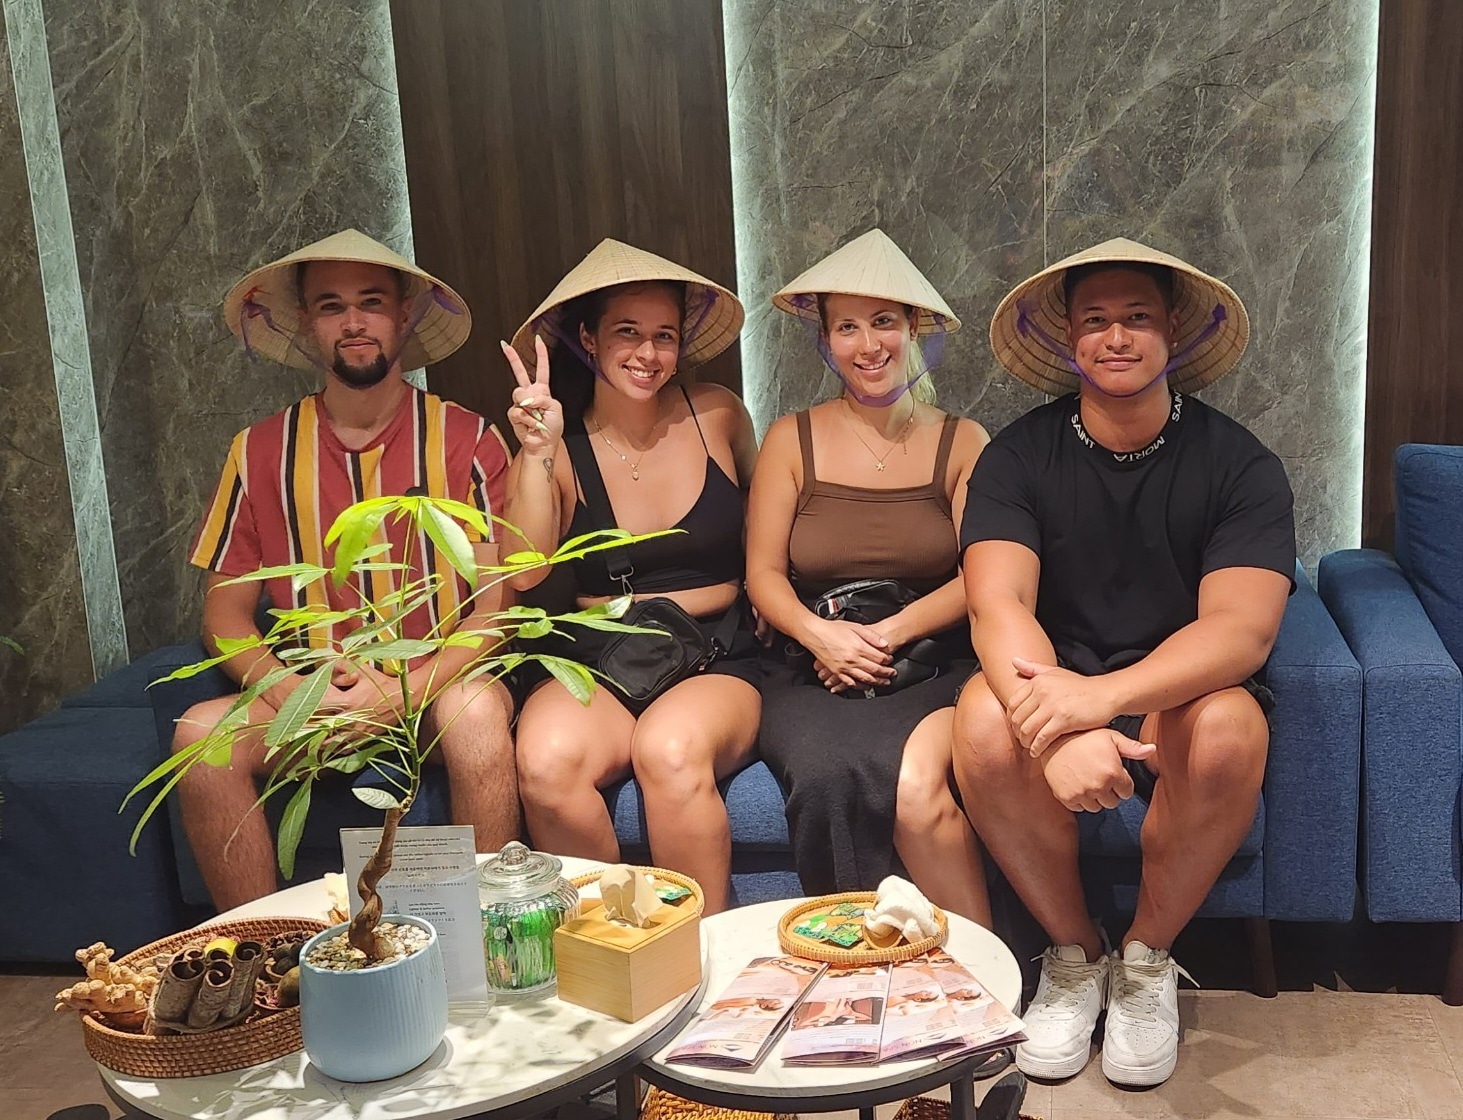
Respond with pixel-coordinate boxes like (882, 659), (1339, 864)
(224, 230), (473, 370)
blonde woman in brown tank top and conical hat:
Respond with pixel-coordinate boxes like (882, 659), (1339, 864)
(748, 230), (990, 924)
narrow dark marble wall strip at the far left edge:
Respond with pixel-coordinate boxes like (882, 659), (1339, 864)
(0, 22), (92, 734)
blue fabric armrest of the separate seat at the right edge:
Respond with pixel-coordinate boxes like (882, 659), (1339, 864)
(1320, 548), (1463, 921)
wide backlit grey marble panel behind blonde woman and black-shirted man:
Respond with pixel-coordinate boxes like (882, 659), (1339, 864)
(724, 0), (1377, 561)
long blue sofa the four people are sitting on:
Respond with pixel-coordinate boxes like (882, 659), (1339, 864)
(0, 572), (1361, 993)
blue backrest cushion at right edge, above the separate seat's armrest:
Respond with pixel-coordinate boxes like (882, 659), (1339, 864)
(1394, 443), (1463, 664)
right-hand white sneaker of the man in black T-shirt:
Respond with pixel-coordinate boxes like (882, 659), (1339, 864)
(1102, 942), (1194, 1086)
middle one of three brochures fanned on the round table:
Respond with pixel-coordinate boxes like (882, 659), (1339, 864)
(783, 965), (891, 1066)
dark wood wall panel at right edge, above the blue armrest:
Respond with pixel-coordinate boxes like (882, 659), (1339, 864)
(1362, 0), (1463, 547)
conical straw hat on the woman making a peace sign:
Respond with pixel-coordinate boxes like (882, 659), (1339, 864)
(514, 237), (746, 370)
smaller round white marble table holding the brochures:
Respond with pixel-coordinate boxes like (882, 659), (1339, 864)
(639, 899), (1021, 1120)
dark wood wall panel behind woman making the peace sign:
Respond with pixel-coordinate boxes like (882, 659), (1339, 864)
(391, 0), (740, 434)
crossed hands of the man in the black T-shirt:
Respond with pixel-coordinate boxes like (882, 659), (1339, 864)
(1007, 658), (1156, 813)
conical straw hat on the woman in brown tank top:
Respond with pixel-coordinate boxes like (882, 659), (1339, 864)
(772, 230), (960, 335)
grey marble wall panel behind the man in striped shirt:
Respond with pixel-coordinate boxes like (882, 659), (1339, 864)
(45, 0), (410, 655)
